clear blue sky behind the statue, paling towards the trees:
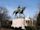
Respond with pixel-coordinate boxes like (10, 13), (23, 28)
(0, 0), (38, 18)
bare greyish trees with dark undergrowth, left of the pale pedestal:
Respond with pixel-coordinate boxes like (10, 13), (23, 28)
(0, 7), (11, 27)
